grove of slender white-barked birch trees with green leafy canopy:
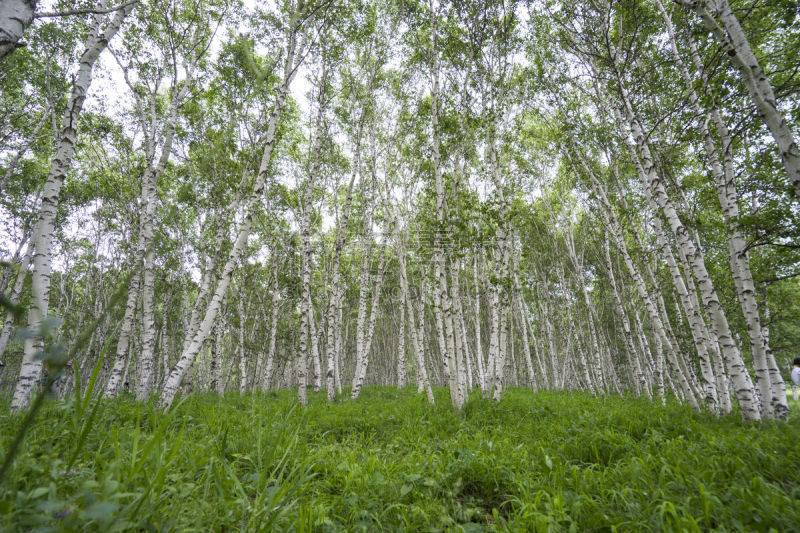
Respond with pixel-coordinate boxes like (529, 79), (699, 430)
(0, 0), (800, 420)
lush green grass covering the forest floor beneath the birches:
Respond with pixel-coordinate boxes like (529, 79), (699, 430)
(0, 388), (800, 532)
